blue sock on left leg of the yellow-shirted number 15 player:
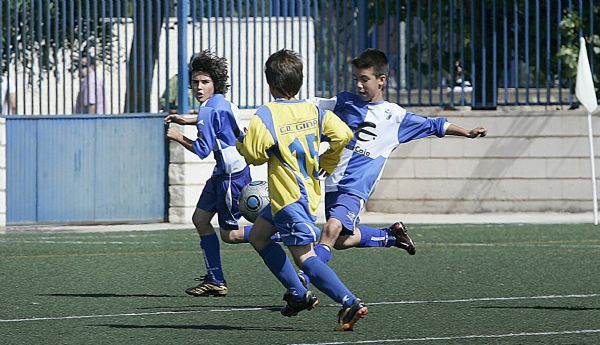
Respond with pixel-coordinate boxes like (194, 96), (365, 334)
(259, 241), (307, 300)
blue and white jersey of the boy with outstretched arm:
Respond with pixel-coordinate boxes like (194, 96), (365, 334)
(311, 92), (450, 200)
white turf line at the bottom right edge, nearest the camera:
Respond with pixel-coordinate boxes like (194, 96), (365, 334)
(289, 329), (600, 345)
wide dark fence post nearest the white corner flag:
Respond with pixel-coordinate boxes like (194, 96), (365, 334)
(471, 0), (497, 110)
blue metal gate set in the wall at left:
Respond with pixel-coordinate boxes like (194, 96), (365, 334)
(6, 114), (168, 225)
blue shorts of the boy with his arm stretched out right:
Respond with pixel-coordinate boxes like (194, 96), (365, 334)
(325, 192), (365, 235)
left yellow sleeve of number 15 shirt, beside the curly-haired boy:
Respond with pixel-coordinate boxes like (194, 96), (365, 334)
(236, 115), (275, 165)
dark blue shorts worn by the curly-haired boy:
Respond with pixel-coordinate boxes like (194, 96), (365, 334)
(196, 167), (252, 230)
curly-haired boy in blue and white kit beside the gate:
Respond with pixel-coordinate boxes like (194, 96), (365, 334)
(165, 50), (252, 296)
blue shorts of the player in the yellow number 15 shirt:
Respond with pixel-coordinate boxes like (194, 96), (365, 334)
(259, 204), (321, 246)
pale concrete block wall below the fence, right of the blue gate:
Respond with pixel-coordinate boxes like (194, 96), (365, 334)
(169, 108), (600, 223)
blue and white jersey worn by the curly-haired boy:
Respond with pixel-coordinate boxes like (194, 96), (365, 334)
(193, 93), (247, 175)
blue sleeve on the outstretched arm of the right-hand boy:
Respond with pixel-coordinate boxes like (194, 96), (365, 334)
(398, 112), (448, 143)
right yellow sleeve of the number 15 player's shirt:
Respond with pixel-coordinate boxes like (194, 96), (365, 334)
(319, 111), (353, 174)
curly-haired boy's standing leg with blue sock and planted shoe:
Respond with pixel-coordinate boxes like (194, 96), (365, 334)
(185, 208), (228, 296)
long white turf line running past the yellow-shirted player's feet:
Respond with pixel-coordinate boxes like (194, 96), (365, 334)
(0, 294), (600, 323)
